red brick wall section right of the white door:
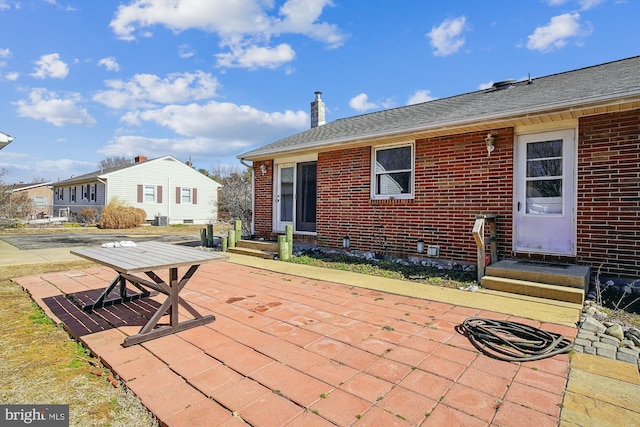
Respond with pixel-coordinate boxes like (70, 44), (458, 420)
(577, 110), (640, 277)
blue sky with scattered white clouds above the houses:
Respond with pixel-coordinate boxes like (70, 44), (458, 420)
(0, 0), (640, 184)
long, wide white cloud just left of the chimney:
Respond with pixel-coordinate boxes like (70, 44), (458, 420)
(101, 101), (309, 156)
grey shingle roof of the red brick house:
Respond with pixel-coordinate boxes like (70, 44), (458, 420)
(238, 56), (640, 159)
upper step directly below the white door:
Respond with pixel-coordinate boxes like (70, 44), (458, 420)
(486, 259), (591, 291)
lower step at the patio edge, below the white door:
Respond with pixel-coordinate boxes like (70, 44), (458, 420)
(481, 276), (585, 304)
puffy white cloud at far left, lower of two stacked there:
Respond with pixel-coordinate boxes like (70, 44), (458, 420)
(15, 88), (96, 126)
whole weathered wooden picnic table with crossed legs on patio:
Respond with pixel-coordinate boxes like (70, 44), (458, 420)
(71, 242), (227, 347)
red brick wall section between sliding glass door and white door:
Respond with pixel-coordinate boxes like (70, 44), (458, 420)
(317, 128), (513, 262)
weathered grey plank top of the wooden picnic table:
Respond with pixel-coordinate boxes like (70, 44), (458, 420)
(71, 242), (227, 274)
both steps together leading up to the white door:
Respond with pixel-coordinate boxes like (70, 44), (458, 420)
(481, 259), (591, 304)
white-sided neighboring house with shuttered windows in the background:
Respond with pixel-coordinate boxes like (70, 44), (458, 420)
(53, 156), (221, 225)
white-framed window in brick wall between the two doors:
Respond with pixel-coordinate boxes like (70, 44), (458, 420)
(371, 144), (414, 199)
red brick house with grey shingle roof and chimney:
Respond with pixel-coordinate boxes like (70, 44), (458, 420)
(238, 57), (640, 277)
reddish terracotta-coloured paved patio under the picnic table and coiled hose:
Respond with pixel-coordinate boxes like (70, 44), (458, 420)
(14, 261), (576, 427)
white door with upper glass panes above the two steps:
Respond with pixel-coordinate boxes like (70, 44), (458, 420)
(513, 130), (576, 255)
